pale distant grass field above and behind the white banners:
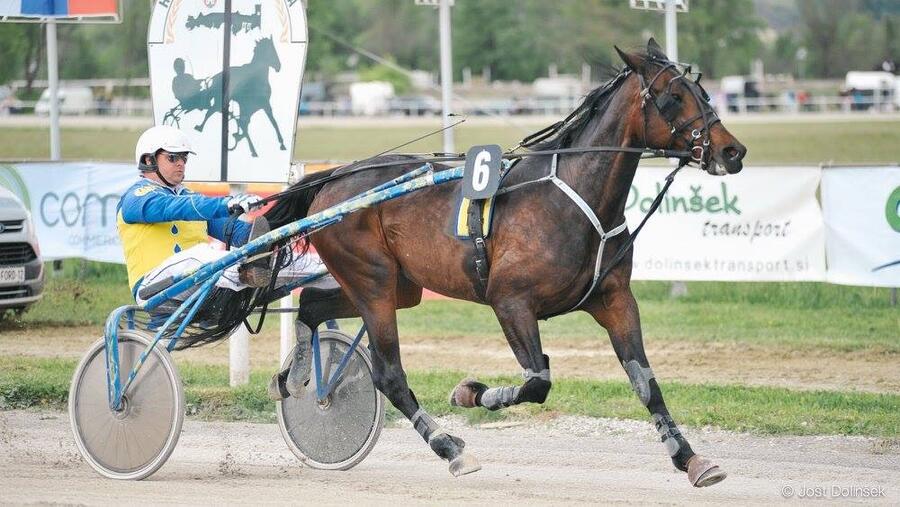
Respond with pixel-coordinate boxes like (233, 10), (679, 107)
(0, 119), (900, 166)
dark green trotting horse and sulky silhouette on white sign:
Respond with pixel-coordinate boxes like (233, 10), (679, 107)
(163, 37), (287, 157)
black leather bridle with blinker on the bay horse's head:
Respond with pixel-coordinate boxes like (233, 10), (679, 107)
(635, 57), (721, 170)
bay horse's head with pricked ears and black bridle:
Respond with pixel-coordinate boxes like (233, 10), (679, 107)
(616, 38), (747, 175)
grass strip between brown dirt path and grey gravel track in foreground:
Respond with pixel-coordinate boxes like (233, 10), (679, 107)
(0, 357), (900, 437)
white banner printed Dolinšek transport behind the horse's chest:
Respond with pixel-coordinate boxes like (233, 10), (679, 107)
(624, 167), (825, 281)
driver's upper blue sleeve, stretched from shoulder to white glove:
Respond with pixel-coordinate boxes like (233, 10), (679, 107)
(120, 185), (228, 224)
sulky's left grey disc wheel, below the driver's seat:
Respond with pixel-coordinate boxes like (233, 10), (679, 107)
(69, 330), (184, 480)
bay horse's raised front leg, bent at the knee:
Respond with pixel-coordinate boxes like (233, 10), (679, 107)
(450, 300), (551, 410)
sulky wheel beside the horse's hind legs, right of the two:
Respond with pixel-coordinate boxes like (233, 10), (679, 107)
(276, 329), (384, 470)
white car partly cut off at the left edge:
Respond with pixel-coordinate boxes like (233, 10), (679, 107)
(0, 187), (44, 320)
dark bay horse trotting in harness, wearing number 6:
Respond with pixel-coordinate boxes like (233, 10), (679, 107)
(266, 39), (747, 487)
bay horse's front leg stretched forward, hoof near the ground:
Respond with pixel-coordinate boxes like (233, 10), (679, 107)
(586, 284), (726, 487)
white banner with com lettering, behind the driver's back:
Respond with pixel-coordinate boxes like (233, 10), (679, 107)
(0, 162), (138, 263)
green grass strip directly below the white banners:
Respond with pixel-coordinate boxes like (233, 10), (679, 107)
(0, 260), (900, 353)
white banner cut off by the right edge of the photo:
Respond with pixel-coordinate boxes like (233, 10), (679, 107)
(822, 167), (900, 287)
